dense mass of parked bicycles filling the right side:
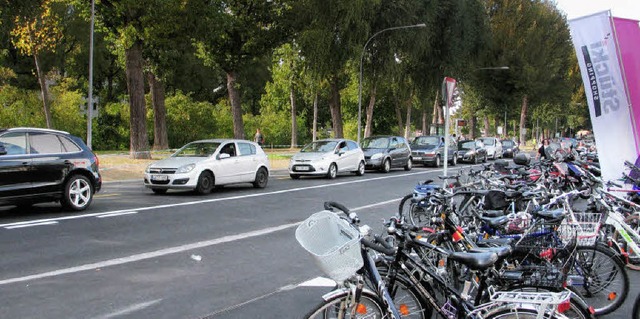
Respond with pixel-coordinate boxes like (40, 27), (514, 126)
(296, 148), (640, 319)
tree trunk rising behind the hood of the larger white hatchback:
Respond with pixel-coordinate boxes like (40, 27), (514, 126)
(147, 72), (169, 150)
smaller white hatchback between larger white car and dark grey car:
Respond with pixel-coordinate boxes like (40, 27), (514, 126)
(289, 139), (365, 179)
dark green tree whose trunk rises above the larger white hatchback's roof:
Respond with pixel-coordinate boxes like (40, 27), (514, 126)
(191, 0), (290, 138)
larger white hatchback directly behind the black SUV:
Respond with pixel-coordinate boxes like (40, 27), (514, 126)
(144, 139), (270, 194)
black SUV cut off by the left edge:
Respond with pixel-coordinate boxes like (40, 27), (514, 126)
(0, 128), (102, 211)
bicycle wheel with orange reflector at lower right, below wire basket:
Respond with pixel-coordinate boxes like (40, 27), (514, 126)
(569, 243), (629, 316)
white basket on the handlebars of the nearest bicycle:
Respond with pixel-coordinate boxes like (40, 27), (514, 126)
(296, 210), (364, 282)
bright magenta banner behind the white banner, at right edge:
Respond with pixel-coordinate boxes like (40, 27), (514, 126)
(613, 17), (640, 153)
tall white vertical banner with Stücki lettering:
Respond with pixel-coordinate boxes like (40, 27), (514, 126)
(569, 11), (637, 180)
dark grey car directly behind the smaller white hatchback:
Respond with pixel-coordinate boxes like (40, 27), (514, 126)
(360, 136), (412, 173)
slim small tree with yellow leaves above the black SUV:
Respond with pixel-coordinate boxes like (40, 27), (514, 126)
(11, 0), (62, 128)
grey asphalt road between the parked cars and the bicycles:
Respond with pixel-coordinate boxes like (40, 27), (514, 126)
(0, 166), (640, 318)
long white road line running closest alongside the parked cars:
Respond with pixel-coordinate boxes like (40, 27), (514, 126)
(0, 167), (463, 228)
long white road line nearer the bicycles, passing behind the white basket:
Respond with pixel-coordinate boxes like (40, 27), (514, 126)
(0, 199), (399, 286)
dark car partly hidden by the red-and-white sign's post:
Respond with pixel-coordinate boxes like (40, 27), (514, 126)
(410, 135), (458, 167)
